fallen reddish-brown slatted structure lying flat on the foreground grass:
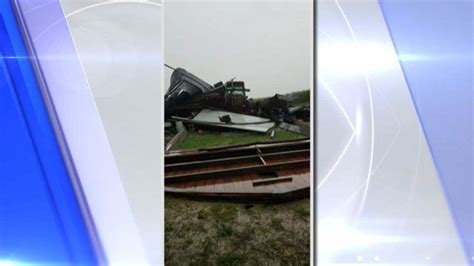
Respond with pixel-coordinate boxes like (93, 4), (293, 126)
(165, 140), (311, 202)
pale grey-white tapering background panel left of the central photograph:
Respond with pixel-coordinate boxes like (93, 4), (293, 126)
(62, 0), (164, 264)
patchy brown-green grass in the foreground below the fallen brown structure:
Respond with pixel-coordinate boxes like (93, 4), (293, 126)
(165, 196), (310, 265)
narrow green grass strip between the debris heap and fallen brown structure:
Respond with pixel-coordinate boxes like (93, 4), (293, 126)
(177, 129), (305, 150)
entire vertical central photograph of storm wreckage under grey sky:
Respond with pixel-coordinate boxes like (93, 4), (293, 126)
(164, 1), (313, 265)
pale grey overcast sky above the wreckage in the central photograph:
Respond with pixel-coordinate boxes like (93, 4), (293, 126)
(164, 0), (313, 97)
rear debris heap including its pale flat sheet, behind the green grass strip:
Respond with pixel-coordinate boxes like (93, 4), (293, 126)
(165, 66), (310, 137)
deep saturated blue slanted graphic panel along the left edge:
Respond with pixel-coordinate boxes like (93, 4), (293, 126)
(0, 1), (96, 265)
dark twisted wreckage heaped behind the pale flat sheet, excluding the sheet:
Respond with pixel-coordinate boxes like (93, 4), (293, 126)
(165, 65), (310, 123)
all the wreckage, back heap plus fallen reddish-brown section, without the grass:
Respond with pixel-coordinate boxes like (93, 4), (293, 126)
(165, 68), (311, 203)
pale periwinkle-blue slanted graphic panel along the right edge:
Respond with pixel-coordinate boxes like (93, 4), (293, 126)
(380, 0), (474, 264)
